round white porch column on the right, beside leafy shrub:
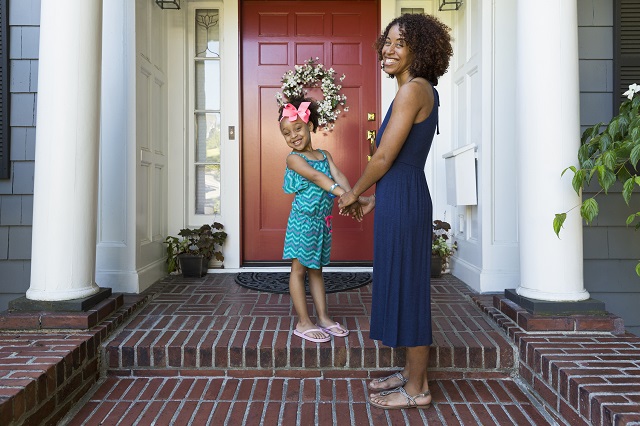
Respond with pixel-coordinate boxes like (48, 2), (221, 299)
(516, 0), (589, 301)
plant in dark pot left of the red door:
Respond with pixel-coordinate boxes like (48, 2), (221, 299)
(164, 222), (227, 277)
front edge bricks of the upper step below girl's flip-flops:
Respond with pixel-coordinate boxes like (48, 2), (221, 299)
(105, 312), (515, 371)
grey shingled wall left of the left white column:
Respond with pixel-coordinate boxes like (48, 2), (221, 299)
(0, 0), (40, 310)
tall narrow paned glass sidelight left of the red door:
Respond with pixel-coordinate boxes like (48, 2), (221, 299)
(192, 9), (222, 215)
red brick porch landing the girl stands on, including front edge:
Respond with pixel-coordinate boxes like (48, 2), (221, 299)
(105, 274), (516, 372)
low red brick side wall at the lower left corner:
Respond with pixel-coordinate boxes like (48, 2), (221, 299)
(0, 295), (146, 425)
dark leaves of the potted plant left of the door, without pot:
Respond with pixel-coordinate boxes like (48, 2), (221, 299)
(164, 222), (227, 273)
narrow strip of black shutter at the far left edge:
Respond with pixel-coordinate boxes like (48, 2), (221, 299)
(0, 0), (11, 179)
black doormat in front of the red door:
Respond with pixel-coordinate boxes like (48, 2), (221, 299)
(235, 272), (371, 294)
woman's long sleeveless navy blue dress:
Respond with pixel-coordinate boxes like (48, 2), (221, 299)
(370, 88), (439, 348)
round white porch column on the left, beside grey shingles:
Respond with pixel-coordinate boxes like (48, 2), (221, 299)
(27, 0), (102, 301)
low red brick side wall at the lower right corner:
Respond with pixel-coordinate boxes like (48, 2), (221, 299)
(475, 296), (640, 426)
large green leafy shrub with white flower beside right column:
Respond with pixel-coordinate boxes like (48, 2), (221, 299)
(553, 84), (640, 275)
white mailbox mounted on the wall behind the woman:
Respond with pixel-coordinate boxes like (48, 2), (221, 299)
(442, 143), (478, 206)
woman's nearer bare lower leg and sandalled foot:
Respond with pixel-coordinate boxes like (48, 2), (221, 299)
(369, 346), (431, 407)
